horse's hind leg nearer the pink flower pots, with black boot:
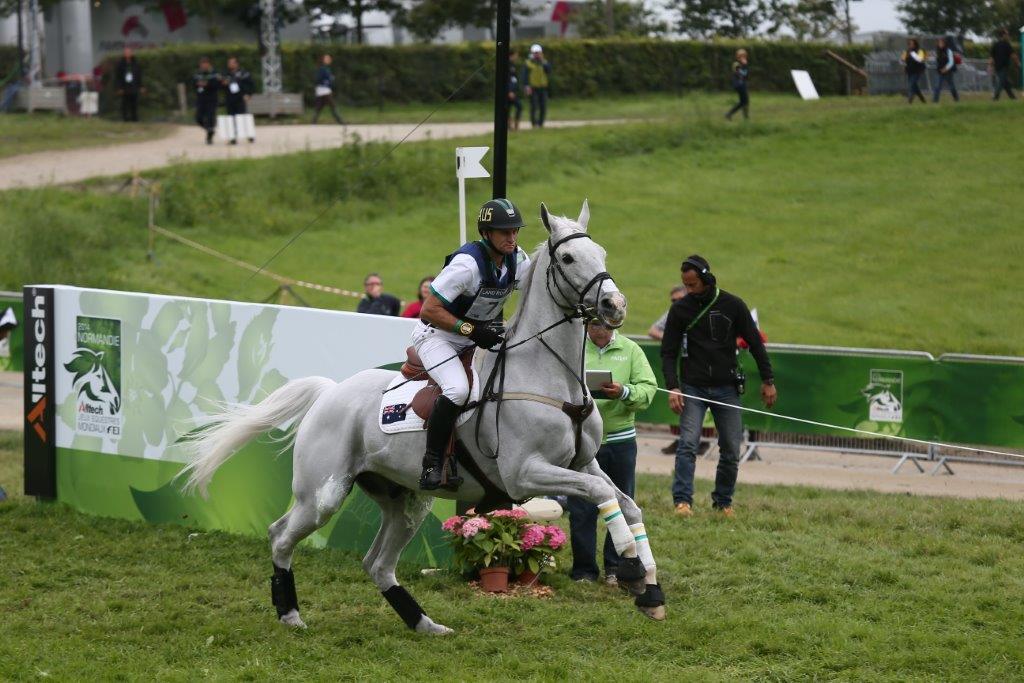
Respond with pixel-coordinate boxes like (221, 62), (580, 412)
(359, 477), (453, 635)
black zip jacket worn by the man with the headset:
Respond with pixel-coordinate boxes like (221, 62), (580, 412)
(662, 288), (773, 389)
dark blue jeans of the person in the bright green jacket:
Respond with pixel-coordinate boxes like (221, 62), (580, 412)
(567, 438), (637, 580)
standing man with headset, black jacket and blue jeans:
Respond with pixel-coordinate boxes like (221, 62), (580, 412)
(662, 254), (777, 517)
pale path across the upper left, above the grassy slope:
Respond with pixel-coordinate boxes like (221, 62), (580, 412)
(0, 121), (602, 189)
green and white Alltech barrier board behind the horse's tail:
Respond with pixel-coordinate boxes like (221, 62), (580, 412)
(23, 286), (455, 564)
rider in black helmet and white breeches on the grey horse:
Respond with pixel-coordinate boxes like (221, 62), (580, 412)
(413, 199), (529, 490)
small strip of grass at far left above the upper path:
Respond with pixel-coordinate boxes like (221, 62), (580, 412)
(0, 112), (171, 159)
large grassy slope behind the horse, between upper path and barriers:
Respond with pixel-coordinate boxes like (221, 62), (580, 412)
(0, 95), (1024, 354)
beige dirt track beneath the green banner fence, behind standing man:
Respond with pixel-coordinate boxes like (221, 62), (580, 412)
(0, 373), (1024, 506)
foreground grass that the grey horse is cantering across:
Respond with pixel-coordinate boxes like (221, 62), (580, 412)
(0, 432), (1024, 681)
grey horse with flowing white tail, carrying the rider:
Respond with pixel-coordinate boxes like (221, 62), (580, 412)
(181, 202), (666, 634)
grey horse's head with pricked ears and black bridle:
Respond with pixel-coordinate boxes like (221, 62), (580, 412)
(541, 200), (627, 328)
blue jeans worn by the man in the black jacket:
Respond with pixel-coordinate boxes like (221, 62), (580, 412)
(672, 384), (743, 508)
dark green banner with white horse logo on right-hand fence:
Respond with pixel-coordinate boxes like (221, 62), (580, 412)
(637, 341), (1024, 447)
